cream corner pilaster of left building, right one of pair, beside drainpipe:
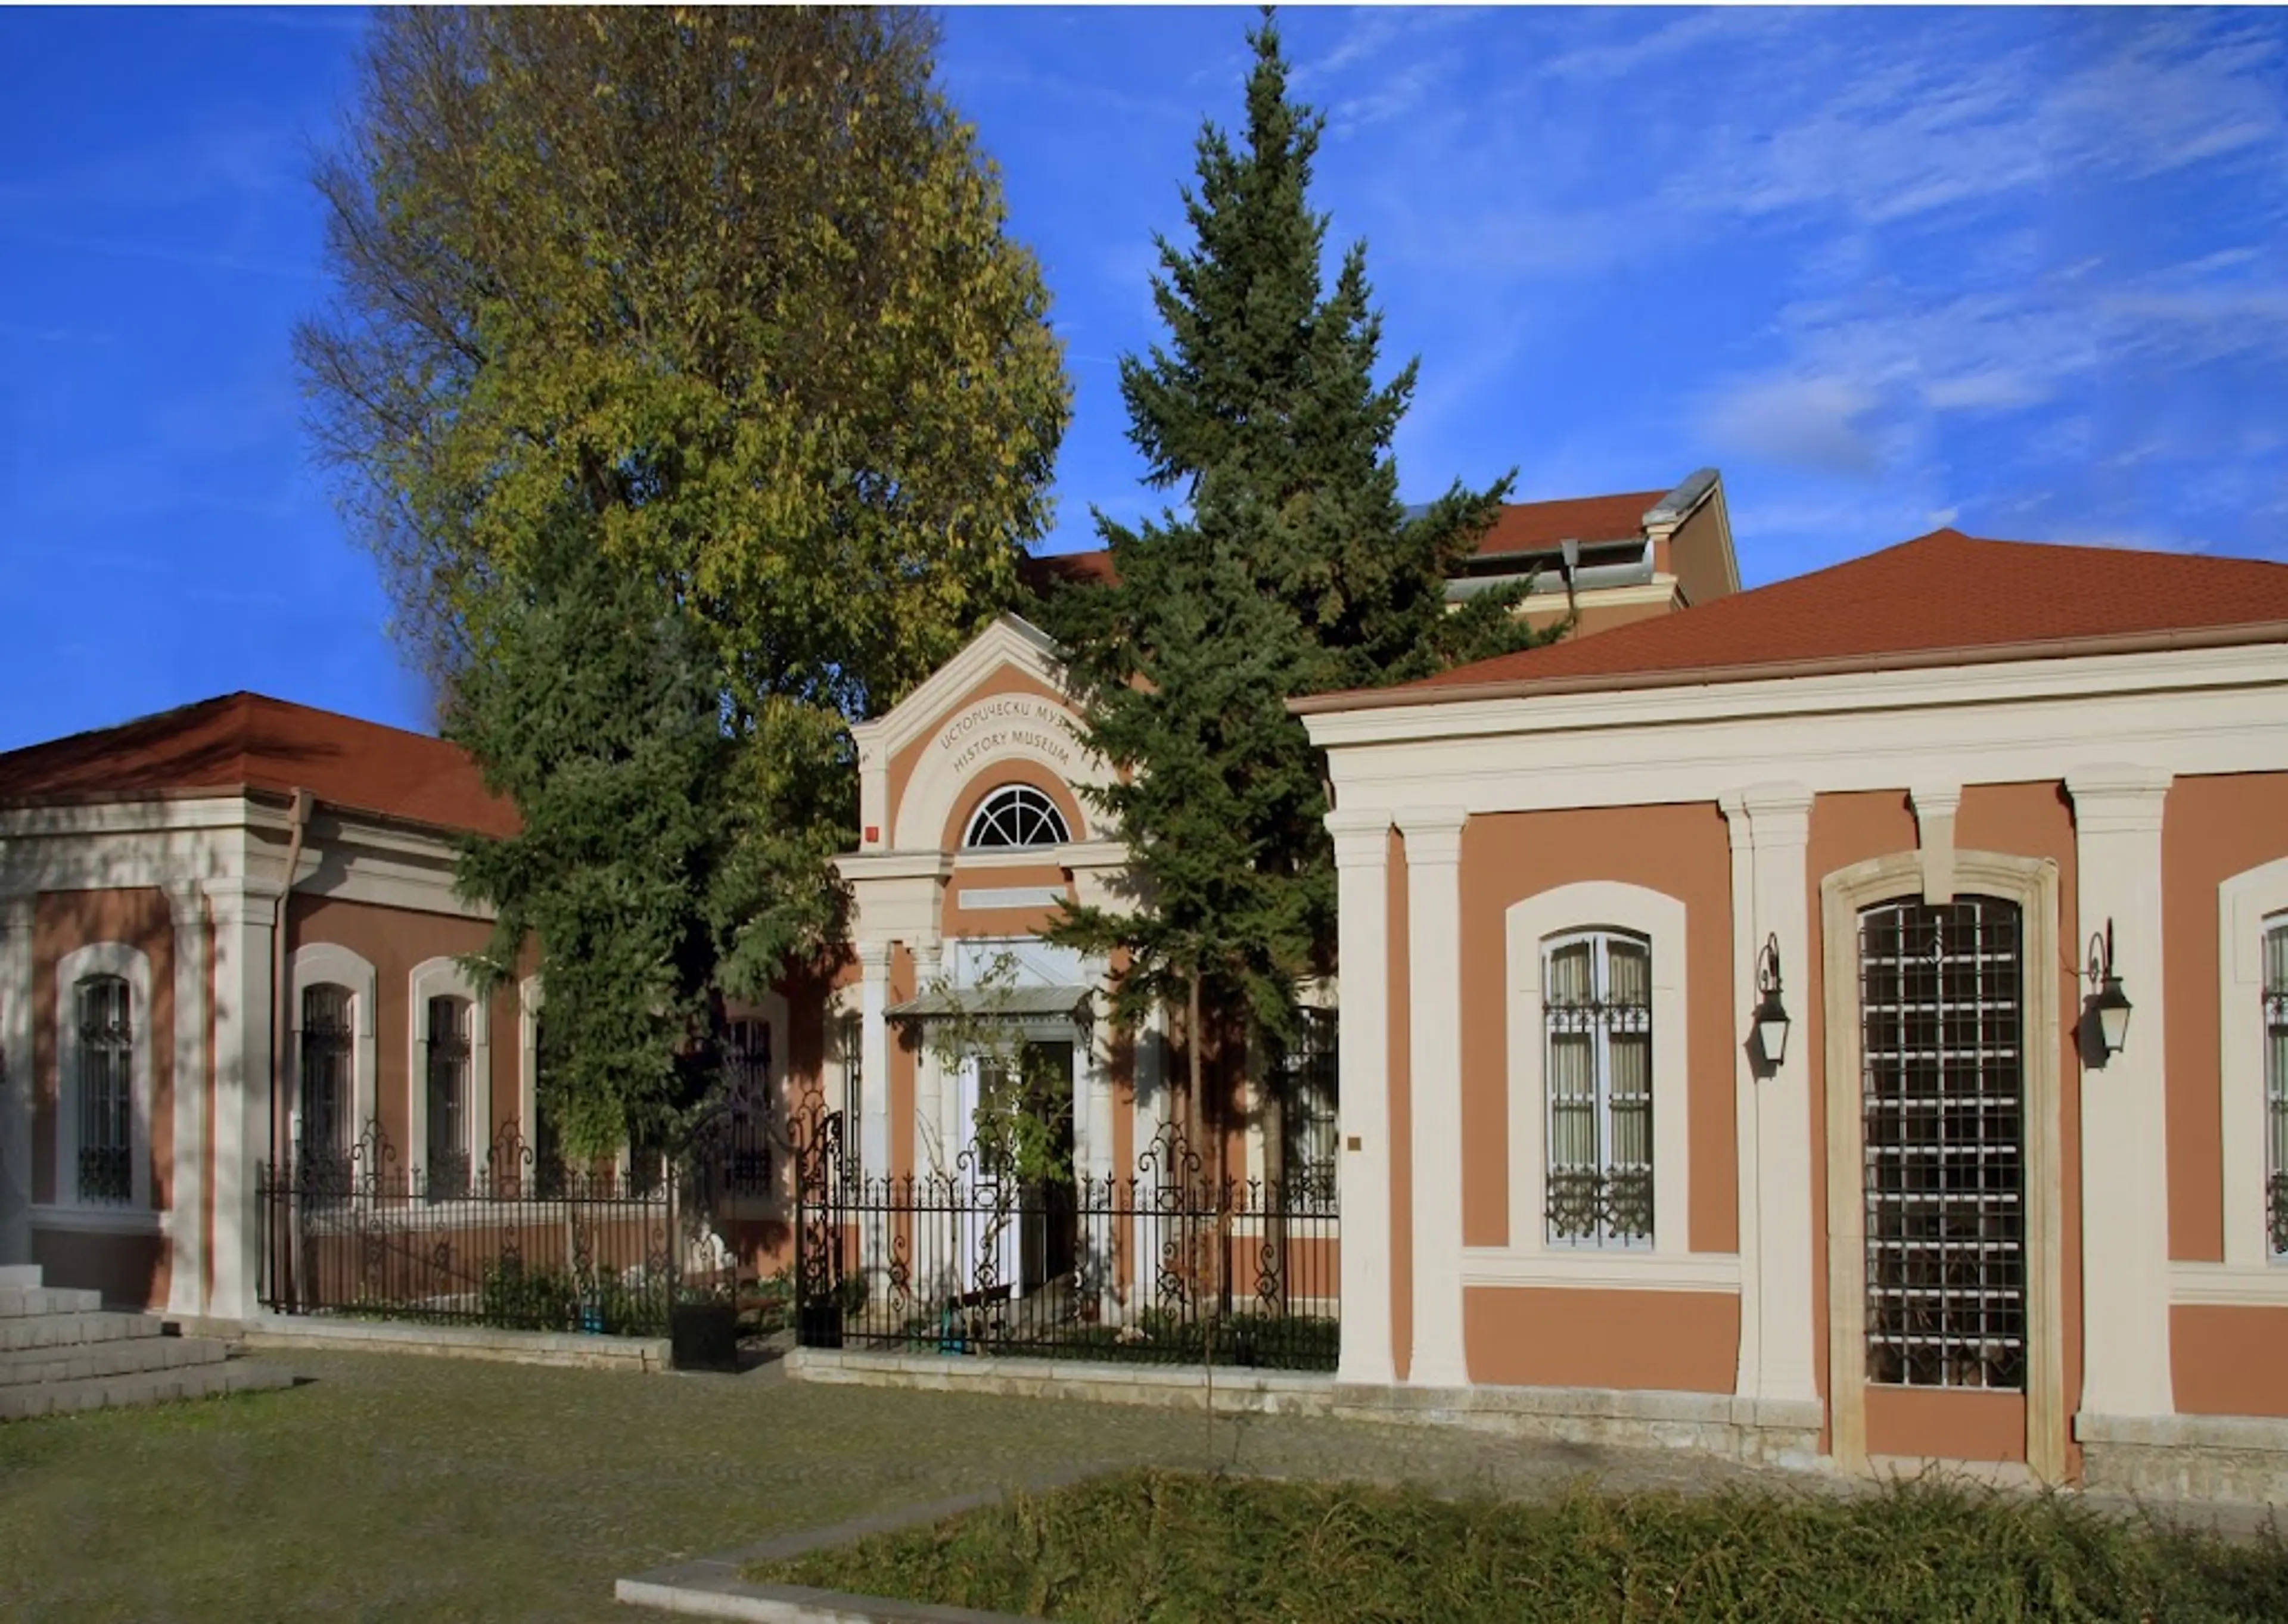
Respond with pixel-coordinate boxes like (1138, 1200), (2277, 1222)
(206, 878), (281, 1320)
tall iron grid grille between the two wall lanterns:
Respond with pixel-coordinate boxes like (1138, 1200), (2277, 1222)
(1858, 897), (2025, 1390)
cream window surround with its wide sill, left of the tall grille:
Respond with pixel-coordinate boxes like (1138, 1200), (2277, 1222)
(1462, 881), (1739, 1292)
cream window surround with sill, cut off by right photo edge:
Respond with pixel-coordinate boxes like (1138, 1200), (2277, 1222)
(2187, 858), (2288, 1306)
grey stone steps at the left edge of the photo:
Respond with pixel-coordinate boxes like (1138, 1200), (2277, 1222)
(0, 1267), (293, 1420)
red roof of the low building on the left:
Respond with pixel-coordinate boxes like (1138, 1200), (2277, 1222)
(0, 693), (517, 835)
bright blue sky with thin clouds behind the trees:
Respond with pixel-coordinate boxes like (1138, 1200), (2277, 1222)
(0, 9), (2288, 748)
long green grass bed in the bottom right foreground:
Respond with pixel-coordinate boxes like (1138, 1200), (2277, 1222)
(748, 1471), (2288, 1624)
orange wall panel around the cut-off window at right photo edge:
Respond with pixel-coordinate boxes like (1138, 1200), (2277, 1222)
(2159, 773), (2288, 1271)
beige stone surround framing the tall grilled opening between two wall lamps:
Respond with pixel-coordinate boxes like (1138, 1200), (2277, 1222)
(1819, 851), (2066, 1485)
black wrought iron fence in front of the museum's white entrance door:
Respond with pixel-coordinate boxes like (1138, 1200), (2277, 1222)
(789, 1112), (1341, 1370)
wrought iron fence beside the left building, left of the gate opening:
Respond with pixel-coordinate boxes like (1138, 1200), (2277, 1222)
(256, 1123), (677, 1336)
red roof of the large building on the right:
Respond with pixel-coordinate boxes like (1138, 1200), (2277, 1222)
(1297, 531), (2288, 711)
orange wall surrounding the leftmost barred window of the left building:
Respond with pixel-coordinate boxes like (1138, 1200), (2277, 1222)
(32, 890), (174, 1217)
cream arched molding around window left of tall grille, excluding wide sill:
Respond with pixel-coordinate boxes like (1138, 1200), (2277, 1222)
(1501, 881), (1684, 1286)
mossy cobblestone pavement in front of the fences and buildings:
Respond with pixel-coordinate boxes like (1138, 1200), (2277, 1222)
(0, 1352), (2251, 1624)
